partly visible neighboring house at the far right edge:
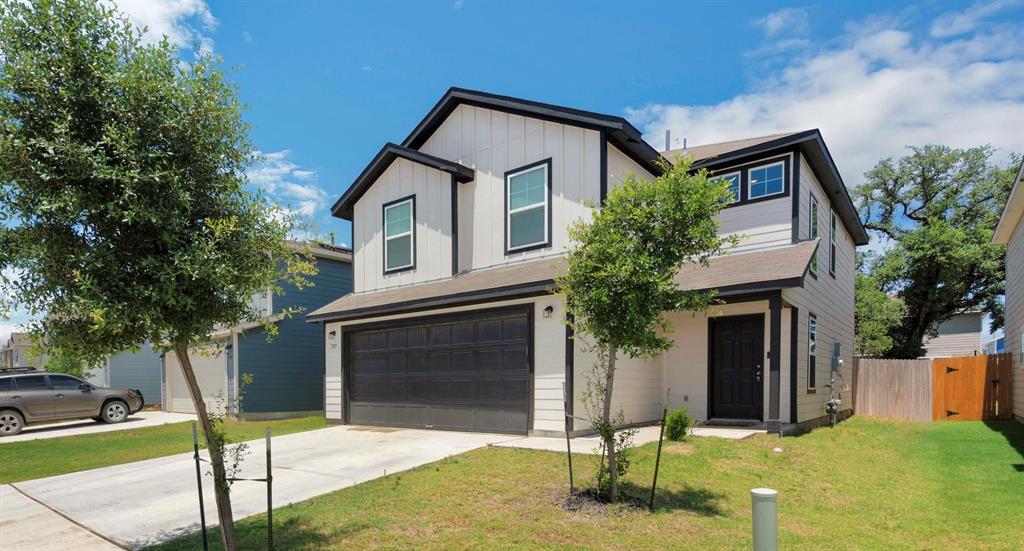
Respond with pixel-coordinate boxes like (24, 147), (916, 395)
(992, 159), (1024, 422)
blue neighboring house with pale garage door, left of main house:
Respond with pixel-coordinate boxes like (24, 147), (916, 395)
(163, 245), (352, 419)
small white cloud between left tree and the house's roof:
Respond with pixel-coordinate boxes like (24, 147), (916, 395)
(246, 150), (329, 217)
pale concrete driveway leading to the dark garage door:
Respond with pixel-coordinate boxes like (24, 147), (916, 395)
(0, 426), (507, 551)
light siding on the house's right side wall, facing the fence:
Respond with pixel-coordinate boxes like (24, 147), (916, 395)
(782, 153), (856, 421)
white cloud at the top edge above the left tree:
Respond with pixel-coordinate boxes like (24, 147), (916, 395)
(108, 0), (217, 51)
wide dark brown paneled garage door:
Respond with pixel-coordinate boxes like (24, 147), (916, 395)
(345, 308), (531, 433)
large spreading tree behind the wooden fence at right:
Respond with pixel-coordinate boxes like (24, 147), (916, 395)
(854, 145), (1020, 358)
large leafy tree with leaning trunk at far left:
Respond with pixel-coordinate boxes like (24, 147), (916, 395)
(0, 0), (312, 550)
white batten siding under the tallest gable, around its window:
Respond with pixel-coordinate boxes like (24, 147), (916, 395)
(419, 104), (600, 269)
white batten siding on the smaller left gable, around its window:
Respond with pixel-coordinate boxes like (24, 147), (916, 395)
(352, 159), (452, 292)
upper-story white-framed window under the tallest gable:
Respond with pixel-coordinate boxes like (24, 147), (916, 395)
(505, 159), (551, 253)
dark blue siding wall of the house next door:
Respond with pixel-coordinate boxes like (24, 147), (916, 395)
(234, 258), (352, 414)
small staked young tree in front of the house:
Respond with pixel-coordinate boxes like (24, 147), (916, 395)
(558, 159), (731, 501)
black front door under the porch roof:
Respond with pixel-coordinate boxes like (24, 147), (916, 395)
(710, 314), (765, 420)
